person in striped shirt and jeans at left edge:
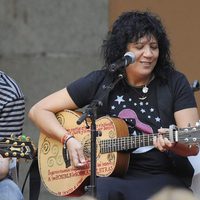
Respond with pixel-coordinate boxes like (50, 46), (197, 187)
(0, 71), (25, 200)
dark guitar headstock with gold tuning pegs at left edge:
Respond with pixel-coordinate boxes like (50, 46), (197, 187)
(0, 135), (36, 159)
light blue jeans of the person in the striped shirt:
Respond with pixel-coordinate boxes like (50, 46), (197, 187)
(0, 178), (24, 200)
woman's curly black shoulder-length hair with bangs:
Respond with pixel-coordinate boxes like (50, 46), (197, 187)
(102, 11), (174, 77)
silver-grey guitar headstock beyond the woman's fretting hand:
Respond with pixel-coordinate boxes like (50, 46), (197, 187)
(178, 122), (200, 144)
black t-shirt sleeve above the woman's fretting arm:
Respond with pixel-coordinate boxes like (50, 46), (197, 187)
(171, 72), (197, 112)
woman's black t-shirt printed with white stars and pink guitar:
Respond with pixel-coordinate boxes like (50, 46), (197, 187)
(67, 70), (196, 173)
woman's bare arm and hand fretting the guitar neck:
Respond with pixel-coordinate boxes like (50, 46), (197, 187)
(154, 108), (199, 156)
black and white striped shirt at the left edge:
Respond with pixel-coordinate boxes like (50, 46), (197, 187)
(0, 71), (25, 137)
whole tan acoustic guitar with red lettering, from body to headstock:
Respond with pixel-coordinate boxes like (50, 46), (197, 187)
(38, 110), (200, 196)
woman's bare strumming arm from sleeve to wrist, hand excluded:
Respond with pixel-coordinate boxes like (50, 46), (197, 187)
(29, 88), (77, 141)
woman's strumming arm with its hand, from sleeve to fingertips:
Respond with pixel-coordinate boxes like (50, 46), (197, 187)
(29, 88), (85, 167)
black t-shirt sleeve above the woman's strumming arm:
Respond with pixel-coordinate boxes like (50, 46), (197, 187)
(67, 70), (105, 108)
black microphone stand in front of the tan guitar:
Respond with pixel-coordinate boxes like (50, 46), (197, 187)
(77, 74), (123, 197)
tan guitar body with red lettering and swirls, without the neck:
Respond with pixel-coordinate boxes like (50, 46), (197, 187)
(38, 110), (129, 196)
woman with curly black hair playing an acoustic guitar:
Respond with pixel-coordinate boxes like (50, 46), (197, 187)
(29, 11), (199, 200)
